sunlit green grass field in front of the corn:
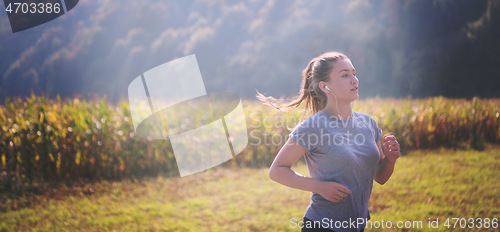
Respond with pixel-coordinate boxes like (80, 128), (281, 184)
(0, 147), (500, 231)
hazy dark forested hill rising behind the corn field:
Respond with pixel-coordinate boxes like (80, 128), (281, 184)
(0, 0), (500, 100)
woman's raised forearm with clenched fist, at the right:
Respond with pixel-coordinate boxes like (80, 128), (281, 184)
(373, 135), (401, 185)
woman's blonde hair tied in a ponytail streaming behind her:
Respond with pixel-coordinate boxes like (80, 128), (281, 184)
(257, 52), (349, 117)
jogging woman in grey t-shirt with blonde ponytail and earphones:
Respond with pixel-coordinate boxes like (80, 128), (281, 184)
(258, 52), (401, 232)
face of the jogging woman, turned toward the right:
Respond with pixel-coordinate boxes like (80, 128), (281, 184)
(325, 59), (359, 103)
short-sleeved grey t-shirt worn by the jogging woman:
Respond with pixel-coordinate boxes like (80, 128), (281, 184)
(290, 111), (382, 232)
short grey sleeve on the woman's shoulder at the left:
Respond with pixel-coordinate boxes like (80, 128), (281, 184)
(290, 119), (320, 153)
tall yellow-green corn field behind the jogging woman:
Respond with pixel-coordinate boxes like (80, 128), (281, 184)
(0, 96), (500, 188)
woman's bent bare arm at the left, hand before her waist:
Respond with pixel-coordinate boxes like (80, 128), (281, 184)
(269, 138), (351, 202)
